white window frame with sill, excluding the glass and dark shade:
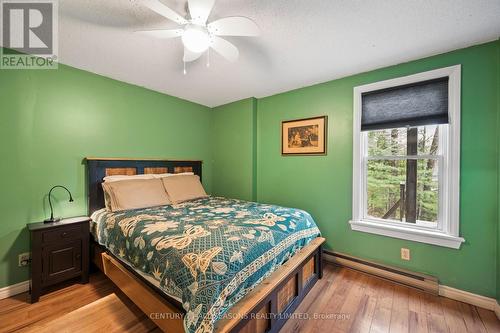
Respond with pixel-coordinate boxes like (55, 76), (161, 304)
(349, 65), (465, 249)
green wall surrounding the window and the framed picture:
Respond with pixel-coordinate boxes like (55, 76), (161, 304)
(214, 41), (500, 297)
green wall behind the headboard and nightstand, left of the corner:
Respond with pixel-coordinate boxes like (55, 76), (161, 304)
(0, 60), (212, 288)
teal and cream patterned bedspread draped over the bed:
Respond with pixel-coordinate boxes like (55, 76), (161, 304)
(91, 197), (320, 332)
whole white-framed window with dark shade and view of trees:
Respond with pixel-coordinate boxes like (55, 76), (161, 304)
(350, 66), (464, 248)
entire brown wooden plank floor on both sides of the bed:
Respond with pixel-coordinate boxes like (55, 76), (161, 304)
(0, 265), (500, 333)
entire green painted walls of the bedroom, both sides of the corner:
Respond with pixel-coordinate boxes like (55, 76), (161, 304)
(0, 41), (500, 299)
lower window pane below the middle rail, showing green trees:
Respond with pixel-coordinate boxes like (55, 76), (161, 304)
(367, 159), (439, 228)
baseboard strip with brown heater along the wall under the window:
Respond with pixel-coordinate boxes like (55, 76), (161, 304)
(323, 250), (500, 319)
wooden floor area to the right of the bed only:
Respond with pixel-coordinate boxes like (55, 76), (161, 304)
(282, 265), (500, 333)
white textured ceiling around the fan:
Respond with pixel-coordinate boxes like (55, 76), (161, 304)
(59, 0), (500, 107)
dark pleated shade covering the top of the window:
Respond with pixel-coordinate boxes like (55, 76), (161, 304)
(361, 77), (448, 131)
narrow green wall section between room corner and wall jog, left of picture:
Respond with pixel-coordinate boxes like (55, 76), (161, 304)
(212, 98), (257, 200)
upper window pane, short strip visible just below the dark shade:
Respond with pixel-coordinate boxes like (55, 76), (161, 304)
(368, 125), (443, 156)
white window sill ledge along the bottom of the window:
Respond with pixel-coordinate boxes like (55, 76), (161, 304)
(349, 221), (465, 249)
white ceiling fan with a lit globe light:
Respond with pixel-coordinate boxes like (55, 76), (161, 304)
(138, 0), (260, 74)
